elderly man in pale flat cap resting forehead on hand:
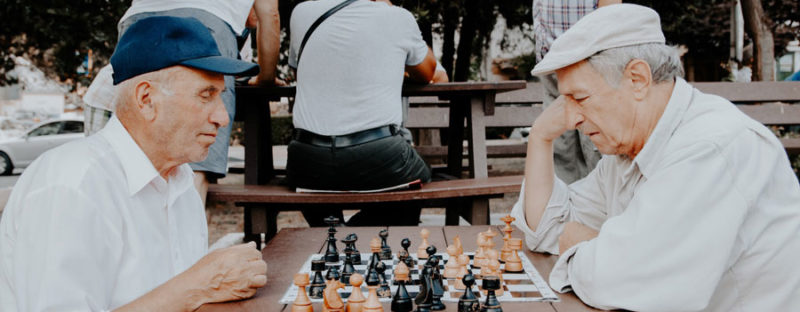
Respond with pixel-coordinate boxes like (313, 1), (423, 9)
(513, 4), (800, 311)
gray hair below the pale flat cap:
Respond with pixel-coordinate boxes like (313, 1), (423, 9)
(587, 43), (683, 88)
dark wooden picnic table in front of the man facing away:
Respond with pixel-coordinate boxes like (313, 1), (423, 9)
(234, 80), (527, 185)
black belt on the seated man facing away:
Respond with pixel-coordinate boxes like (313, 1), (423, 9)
(292, 125), (398, 148)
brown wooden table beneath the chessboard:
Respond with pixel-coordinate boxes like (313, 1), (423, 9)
(195, 225), (594, 312)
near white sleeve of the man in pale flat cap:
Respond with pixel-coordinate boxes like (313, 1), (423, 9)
(550, 143), (755, 311)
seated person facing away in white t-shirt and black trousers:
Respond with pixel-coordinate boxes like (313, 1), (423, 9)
(286, 0), (436, 226)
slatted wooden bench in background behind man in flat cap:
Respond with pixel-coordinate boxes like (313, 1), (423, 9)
(406, 81), (800, 158)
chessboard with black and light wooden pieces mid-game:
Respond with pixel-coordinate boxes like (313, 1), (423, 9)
(280, 216), (559, 311)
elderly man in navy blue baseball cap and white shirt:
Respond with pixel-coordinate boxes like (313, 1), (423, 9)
(0, 17), (267, 311)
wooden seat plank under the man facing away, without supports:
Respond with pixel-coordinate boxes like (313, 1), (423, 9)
(208, 176), (522, 204)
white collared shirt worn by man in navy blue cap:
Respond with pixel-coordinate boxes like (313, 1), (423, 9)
(0, 117), (208, 311)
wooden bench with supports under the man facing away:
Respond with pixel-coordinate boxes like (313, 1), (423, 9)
(208, 176), (522, 246)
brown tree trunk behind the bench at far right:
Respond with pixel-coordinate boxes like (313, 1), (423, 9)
(741, 0), (775, 81)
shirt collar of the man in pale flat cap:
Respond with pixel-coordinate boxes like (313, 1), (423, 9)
(633, 77), (694, 176)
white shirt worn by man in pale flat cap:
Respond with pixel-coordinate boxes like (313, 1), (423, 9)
(512, 79), (800, 311)
